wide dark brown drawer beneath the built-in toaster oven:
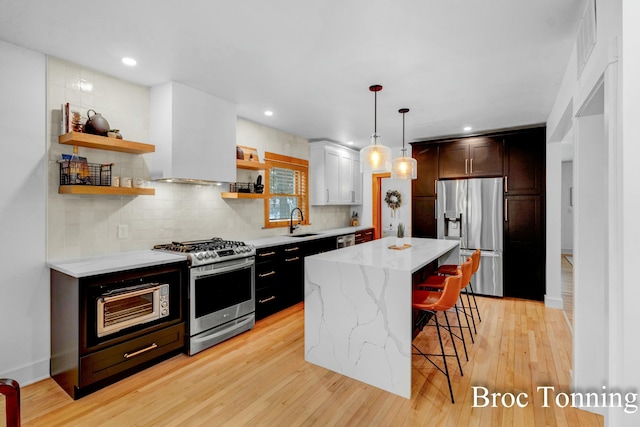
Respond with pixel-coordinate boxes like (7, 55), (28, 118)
(80, 322), (185, 388)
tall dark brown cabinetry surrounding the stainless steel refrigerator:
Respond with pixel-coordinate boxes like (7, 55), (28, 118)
(411, 126), (546, 300)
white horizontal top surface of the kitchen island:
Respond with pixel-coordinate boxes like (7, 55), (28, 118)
(308, 237), (459, 273)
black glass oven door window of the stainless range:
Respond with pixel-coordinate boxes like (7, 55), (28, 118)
(192, 267), (253, 319)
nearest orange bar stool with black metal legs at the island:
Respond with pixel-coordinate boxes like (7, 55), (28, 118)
(412, 270), (464, 403)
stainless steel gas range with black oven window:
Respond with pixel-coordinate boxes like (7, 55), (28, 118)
(154, 237), (256, 355)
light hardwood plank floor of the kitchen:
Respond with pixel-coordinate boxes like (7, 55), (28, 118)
(5, 298), (603, 427)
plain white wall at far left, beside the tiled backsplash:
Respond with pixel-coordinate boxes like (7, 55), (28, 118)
(0, 41), (50, 385)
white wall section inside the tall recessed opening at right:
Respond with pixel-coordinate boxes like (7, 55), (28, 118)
(573, 115), (608, 396)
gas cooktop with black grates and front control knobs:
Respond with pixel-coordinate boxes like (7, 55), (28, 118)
(153, 237), (256, 266)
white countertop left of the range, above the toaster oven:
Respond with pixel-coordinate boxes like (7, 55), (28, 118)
(47, 250), (187, 278)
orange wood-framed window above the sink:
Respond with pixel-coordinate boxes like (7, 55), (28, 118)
(264, 152), (310, 228)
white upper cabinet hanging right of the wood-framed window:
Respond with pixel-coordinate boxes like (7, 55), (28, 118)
(309, 141), (362, 205)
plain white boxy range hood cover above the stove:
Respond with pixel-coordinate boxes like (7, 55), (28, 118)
(149, 82), (236, 182)
